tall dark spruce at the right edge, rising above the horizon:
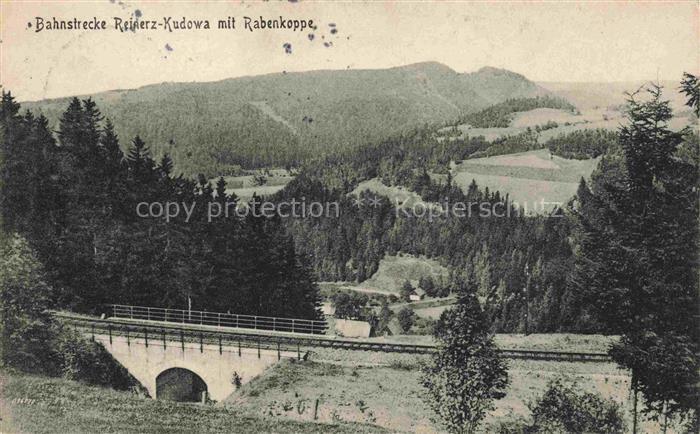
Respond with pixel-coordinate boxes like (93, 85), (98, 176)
(572, 85), (700, 431)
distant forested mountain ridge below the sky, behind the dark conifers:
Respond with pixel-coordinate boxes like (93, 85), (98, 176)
(24, 63), (548, 178)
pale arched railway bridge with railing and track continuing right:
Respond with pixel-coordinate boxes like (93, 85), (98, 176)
(54, 305), (610, 401)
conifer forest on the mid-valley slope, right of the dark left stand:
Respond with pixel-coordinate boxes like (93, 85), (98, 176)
(278, 133), (595, 331)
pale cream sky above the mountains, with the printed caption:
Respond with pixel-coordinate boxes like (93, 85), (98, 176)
(0, 0), (700, 101)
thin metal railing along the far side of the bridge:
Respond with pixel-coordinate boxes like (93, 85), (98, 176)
(108, 304), (327, 334)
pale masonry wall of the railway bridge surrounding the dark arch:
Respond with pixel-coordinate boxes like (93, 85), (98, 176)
(95, 334), (298, 401)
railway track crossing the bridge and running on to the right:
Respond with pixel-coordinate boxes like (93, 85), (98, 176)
(53, 312), (612, 363)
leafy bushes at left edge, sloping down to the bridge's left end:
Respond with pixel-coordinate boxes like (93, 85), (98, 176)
(0, 235), (138, 390)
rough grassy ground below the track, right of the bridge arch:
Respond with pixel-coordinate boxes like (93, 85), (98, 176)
(226, 349), (672, 433)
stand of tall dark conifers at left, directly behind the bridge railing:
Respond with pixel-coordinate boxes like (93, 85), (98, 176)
(0, 92), (320, 319)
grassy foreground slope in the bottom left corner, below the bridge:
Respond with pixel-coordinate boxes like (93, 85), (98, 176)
(0, 372), (381, 433)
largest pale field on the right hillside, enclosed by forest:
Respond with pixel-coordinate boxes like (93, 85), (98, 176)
(452, 149), (598, 212)
